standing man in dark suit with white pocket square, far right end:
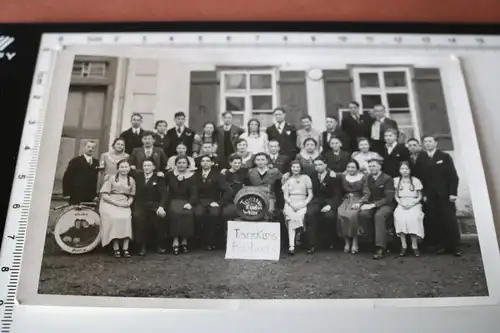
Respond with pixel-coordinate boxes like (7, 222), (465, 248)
(415, 136), (461, 256)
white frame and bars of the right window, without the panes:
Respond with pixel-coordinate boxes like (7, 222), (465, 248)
(352, 67), (420, 139)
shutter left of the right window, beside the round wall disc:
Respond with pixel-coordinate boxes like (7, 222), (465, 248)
(323, 69), (354, 118)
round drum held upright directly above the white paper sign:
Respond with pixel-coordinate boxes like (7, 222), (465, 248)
(234, 186), (271, 221)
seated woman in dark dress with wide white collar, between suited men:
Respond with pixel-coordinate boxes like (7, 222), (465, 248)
(166, 156), (197, 255)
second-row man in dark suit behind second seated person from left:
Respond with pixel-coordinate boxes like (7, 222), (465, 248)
(129, 132), (167, 177)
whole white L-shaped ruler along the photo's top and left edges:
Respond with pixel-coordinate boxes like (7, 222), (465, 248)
(0, 32), (500, 333)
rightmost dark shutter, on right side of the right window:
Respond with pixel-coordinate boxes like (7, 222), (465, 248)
(413, 68), (453, 150)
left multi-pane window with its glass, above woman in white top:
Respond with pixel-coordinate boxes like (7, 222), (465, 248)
(220, 70), (276, 130)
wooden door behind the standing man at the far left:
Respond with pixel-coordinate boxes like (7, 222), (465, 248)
(53, 85), (111, 195)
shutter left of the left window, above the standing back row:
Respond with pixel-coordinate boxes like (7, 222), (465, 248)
(189, 71), (219, 132)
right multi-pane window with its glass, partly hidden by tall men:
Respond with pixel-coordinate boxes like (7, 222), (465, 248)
(353, 68), (420, 139)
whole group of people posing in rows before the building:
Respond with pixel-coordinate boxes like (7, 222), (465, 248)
(63, 102), (461, 259)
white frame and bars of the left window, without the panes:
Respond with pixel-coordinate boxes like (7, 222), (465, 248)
(219, 68), (278, 130)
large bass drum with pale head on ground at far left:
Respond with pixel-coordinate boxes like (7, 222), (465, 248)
(54, 206), (101, 254)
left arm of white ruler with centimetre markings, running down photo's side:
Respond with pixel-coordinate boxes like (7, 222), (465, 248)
(0, 44), (56, 333)
